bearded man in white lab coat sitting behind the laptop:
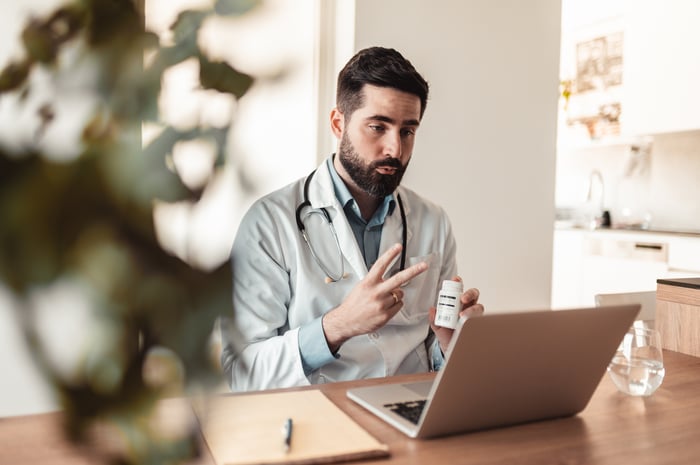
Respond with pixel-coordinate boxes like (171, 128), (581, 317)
(222, 47), (483, 390)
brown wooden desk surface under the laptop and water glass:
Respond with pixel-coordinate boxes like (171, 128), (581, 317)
(0, 351), (700, 465)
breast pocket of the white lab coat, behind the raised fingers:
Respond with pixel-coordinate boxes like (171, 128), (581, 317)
(391, 252), (440, 324)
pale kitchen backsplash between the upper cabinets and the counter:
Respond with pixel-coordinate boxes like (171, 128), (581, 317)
(556, 130), (700, 232)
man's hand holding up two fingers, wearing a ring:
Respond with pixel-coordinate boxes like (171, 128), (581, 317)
(323, 244), (428, 353)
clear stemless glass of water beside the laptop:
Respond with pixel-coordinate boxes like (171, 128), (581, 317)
(608, 326), (666, 396)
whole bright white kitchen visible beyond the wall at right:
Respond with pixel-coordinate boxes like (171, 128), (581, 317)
(552, 0), (700, 308)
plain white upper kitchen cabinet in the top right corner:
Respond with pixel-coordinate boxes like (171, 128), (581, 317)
(621, 0), (700, 134)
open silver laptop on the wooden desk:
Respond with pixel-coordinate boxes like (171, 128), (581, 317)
(347, 304), (640, 438)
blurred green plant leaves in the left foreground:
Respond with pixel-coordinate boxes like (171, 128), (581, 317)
(0, 0), (257, 463)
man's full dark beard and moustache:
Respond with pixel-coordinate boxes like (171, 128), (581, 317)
(338, 130), (408, 199)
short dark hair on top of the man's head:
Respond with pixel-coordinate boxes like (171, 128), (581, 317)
(336, 47), (428, 119)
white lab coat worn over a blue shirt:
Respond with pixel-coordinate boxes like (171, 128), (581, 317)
(222, 161), (457, 391)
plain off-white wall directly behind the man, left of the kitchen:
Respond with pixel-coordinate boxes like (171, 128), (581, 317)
(355, 0), (561, 312)
